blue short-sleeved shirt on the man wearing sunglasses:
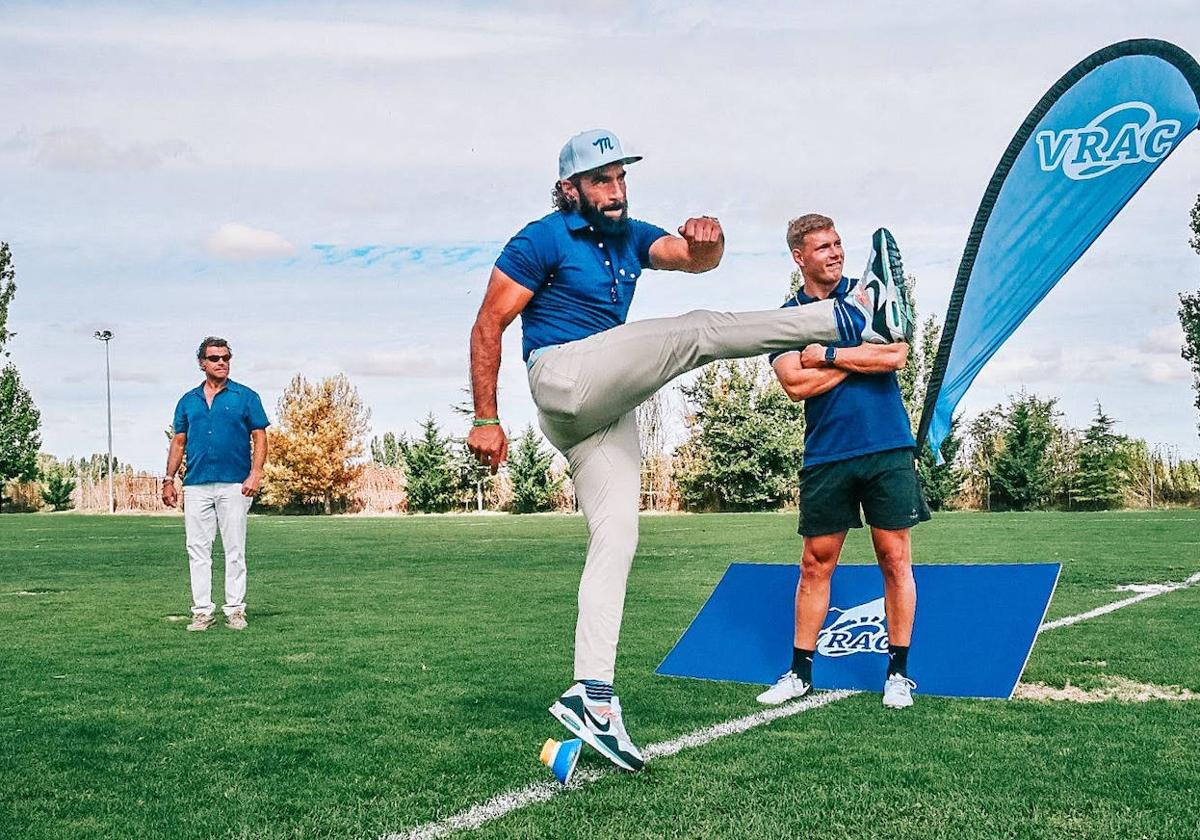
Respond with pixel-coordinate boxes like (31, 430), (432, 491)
(172, 379), (271, 485)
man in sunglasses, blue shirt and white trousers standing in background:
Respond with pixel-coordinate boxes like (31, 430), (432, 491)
(162, 336), (271, 630)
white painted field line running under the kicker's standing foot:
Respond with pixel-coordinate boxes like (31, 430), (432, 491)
(380, 572), (1200, 840)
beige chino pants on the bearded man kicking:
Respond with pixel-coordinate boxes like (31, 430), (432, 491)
(529, 300), (838, 683)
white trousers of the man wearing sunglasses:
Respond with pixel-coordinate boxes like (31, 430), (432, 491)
(184, 482), (254, 616)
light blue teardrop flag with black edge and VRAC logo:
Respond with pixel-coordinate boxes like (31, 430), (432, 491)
(917, 38), (1200, 462)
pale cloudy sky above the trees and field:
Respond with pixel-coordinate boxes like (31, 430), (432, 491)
(0, 0), (1200, 472)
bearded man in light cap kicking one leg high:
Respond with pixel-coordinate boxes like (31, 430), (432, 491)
(467, 130), (904, 770)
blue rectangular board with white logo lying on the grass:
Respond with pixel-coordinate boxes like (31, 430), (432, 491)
(656, 563), (1062, 698)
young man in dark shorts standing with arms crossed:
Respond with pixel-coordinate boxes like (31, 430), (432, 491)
(758, 214), (929, 708)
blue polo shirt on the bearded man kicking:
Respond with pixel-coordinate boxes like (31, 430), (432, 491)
(496, 211), (670, 360)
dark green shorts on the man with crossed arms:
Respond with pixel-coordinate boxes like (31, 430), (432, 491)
(800, 449), (929, 536)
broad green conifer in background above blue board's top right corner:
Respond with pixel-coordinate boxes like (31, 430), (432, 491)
(988, 394), (1062, 510)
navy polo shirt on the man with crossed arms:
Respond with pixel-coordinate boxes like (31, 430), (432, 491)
(769, 277), (917, 467)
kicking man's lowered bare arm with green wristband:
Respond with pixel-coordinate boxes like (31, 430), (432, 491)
(467, 268), (533, 473)
